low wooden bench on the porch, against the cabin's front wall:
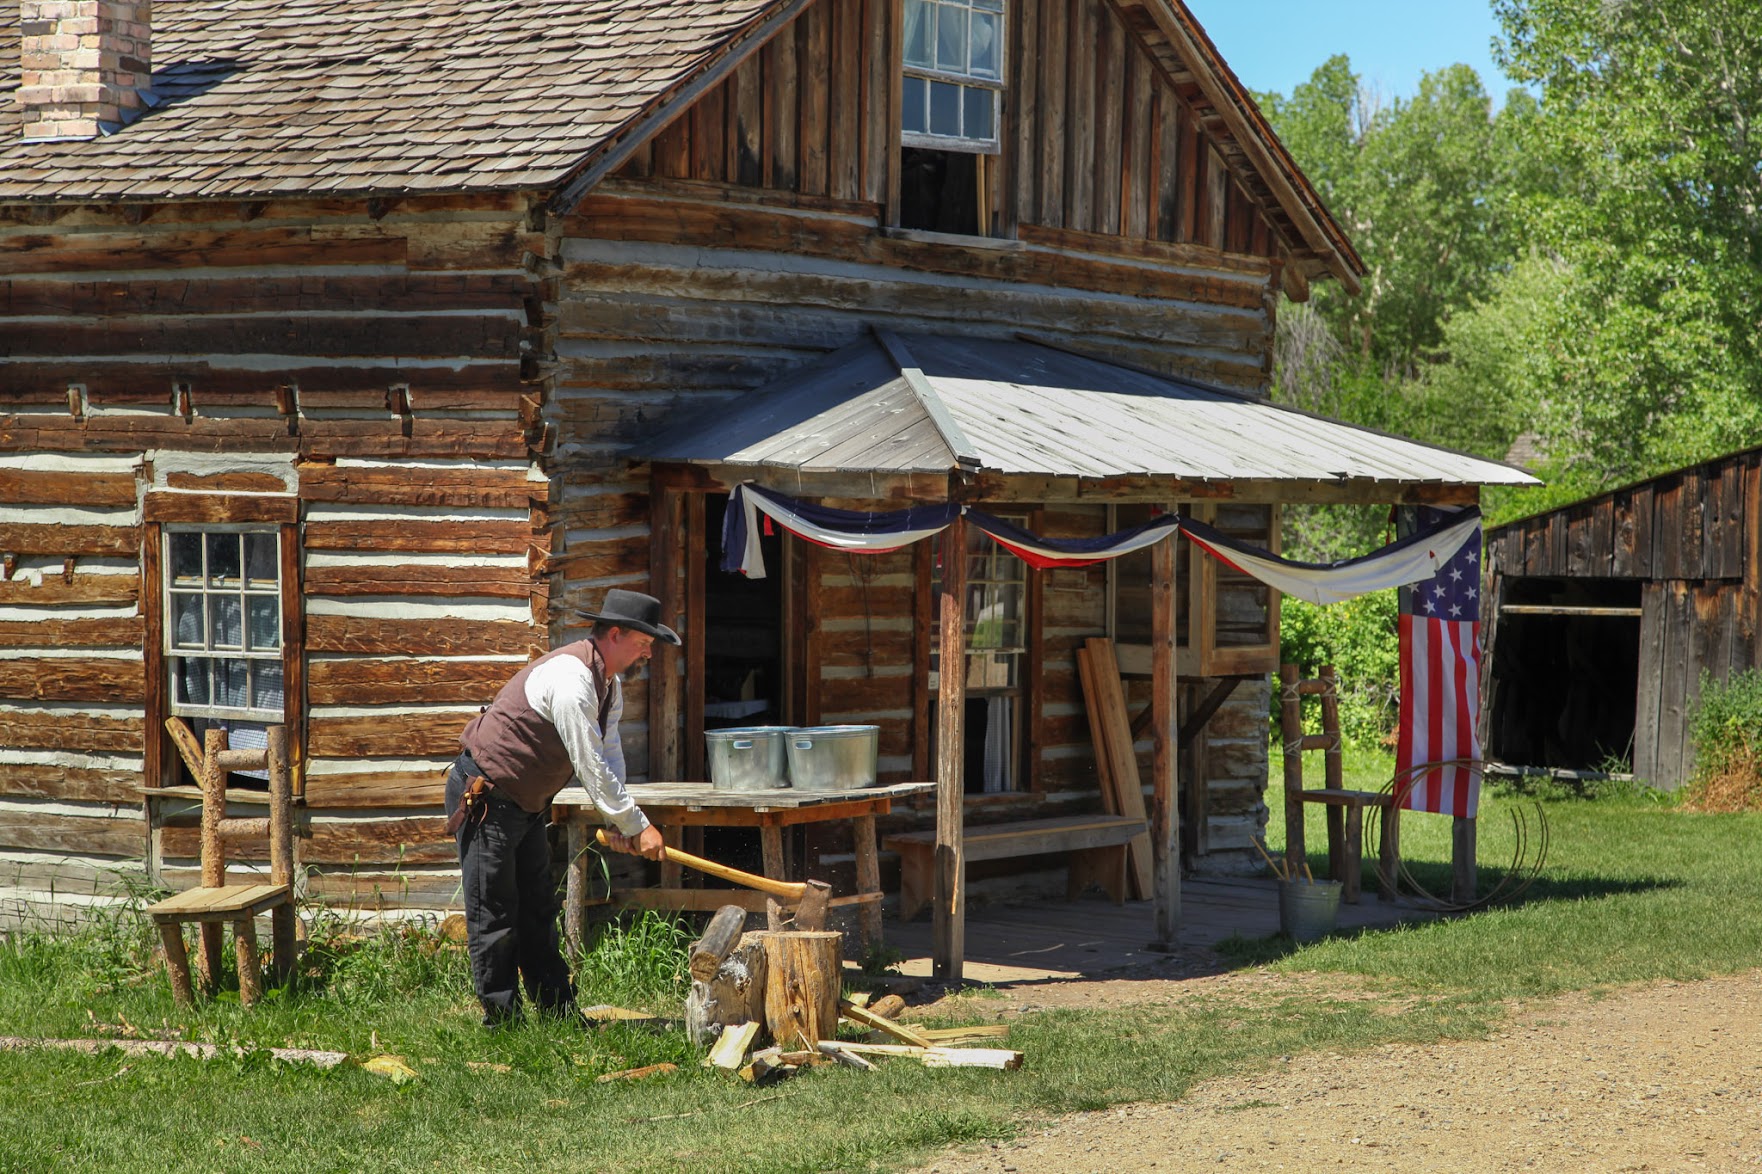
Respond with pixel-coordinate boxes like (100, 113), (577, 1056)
(881, 814), (1145, 922)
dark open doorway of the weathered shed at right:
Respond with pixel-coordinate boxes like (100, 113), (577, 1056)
(1487, 578), (1640, 772)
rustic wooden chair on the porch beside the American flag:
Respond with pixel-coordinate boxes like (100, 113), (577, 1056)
(1279, 665), (1401, 904)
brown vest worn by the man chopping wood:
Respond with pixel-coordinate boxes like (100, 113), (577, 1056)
(458, 640), (618, 814)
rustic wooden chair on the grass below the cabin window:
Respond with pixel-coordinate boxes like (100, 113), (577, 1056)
(146, 717), (296, 1007)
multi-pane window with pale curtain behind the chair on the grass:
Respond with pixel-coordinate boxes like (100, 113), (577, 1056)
(164, 525), (282, 728)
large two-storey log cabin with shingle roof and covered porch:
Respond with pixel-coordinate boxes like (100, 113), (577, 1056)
(0, 0), (1524, 944)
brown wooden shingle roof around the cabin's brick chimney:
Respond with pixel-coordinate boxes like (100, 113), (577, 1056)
(0, 0), (777, 201)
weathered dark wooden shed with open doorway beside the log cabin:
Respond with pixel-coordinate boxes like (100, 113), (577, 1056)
(1484, 450), (1762, 788)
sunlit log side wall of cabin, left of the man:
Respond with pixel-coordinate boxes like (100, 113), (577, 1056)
(0, 197), (552, 917)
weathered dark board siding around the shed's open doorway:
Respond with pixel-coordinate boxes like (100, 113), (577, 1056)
(1487, 450), (1762, 786)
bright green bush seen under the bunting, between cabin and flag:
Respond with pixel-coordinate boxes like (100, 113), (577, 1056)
(1272, 591), (1401, 746)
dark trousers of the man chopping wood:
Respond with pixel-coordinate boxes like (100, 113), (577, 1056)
(446, 754), (574, 1022)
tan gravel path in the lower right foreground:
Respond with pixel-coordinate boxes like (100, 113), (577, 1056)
(923, 971), (1762, 1174)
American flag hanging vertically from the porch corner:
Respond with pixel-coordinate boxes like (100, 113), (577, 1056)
(1396, 506), (1480, 818)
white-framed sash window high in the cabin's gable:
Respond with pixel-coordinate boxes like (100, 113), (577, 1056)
(902, 0), (1004, 153)
